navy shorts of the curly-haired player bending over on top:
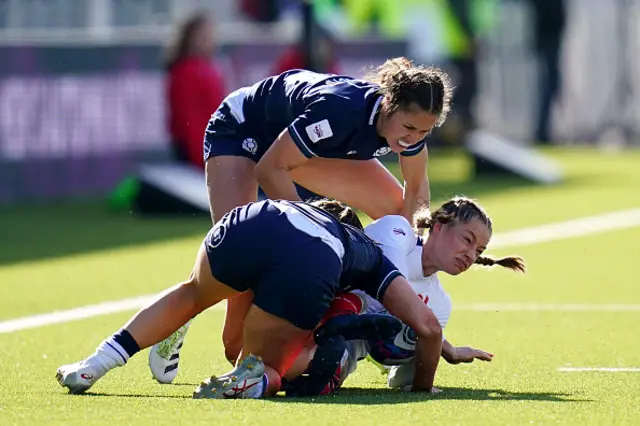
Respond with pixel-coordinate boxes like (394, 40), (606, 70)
(204, 88), (273, 163)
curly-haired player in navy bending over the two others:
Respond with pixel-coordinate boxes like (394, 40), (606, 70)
(150, 58), (452, 372)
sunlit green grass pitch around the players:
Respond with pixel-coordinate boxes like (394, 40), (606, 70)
(0, 150), (640, 426)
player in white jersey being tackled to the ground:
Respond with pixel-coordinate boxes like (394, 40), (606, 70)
(284, 198), (524, 393)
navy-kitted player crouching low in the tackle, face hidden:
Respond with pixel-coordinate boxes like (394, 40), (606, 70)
(56, 200), (442, 398)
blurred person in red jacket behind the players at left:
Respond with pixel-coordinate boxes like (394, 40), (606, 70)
(166, 13), (226, 169)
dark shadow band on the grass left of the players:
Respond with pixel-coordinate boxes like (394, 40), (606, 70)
(0, 201), (211, 265)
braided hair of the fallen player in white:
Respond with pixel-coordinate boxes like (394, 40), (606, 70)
(413, 197), (525, 272)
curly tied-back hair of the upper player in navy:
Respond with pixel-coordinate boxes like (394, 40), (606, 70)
(365, 57), (453, 127)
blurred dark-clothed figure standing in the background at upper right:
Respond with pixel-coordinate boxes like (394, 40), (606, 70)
(529, 0), (567, 144)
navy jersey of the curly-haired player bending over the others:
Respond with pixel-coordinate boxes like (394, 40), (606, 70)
(242, 70), (425, 160)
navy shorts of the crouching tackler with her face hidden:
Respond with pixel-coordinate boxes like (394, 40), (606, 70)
(204, 201), (342, 330)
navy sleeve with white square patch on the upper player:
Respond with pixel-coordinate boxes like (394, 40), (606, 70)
(288, 95), (358, 158)
